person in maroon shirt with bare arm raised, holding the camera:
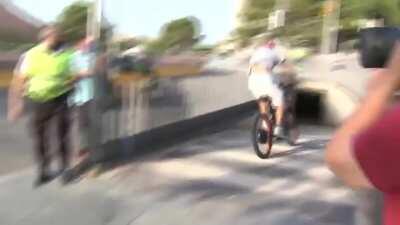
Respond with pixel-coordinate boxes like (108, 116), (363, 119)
(326, 44), (400, 225)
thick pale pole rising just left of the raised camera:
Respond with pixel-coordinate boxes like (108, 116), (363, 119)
(321, 0), (341, 54)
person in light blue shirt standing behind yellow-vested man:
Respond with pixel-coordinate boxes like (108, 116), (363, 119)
(70, 37), (95, 162)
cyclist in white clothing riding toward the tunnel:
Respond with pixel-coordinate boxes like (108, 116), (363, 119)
(248, 40), (285, 137)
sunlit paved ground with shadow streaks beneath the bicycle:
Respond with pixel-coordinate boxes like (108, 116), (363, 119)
(0, 121), (362, 225)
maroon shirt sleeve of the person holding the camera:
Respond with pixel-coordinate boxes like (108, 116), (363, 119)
(353, 105), (400, 193)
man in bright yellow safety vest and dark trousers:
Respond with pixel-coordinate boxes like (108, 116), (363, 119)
(8, 26), (79, 186)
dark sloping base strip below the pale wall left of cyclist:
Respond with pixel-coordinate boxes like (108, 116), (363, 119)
(101, 101), (256, 163)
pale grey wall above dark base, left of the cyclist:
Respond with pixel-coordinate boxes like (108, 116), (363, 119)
(103, 67), (253, 143)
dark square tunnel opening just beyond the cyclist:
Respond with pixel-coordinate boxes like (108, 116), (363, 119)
(296, 90), (324, 124)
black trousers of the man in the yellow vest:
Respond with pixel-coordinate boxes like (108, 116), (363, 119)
(29, 94), (71, 173)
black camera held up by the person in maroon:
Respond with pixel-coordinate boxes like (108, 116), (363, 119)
(359, 27), (400, 68)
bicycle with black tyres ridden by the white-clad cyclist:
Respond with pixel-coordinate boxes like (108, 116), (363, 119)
(251, 83), (299, 159)
